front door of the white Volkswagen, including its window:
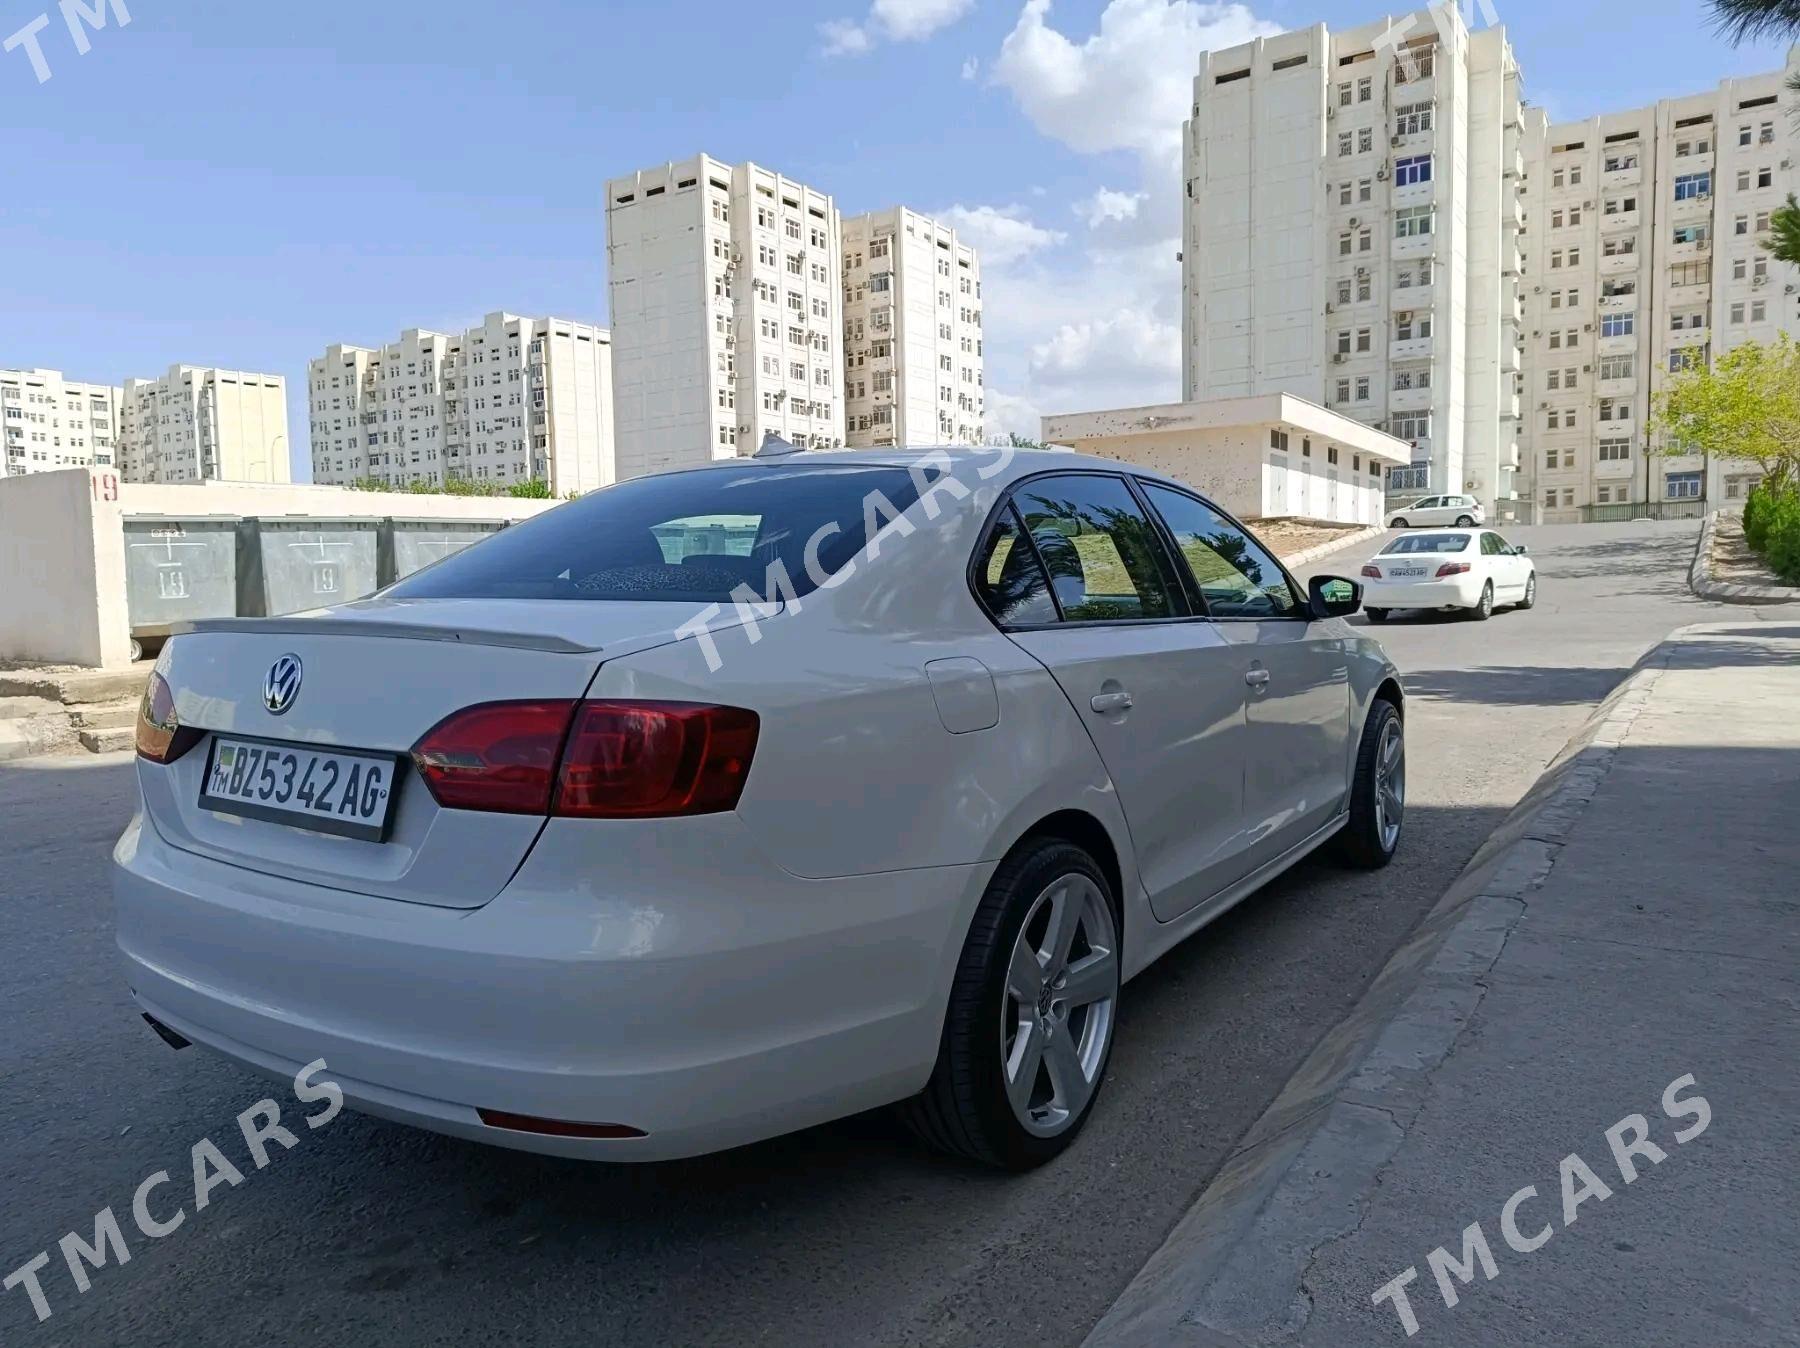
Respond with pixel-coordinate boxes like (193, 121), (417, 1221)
(1141, 479), (1350, 871)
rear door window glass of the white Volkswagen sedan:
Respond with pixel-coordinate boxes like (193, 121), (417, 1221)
(1013, 473), (1179, 623)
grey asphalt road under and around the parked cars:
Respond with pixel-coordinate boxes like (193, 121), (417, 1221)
(0, 524), (1773, 1348)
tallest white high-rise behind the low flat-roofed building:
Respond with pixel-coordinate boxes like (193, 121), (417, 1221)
(1183, 5), (1523, 502)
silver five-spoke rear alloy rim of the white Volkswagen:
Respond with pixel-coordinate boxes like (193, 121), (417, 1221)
(999, 871), (1120, 1137)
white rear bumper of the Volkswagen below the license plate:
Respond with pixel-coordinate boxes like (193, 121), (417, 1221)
(113, 815), (992, 1161)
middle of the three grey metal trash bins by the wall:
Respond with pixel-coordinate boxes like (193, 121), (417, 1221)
(238, 517), (380, 617)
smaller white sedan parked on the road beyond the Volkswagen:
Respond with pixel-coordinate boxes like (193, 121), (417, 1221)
(1363, 529), (1537, 623)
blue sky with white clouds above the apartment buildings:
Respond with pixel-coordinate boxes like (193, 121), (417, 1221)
(0, 0), (1782, 477)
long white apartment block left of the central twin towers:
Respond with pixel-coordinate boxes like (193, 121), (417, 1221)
(306, 313), (614, 495)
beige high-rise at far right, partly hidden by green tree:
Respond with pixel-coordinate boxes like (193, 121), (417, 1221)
(1523, 47), (1800, 520)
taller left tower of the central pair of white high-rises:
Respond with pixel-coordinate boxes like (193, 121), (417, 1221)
(607, 155), (844, 479)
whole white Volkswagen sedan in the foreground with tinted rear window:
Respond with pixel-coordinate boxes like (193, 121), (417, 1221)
(115, 452), (1406, 1168)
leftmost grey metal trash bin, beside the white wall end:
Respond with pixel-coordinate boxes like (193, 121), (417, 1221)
(124, 515), (239, 652)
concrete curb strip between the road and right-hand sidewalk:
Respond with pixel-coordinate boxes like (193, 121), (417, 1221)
(1084, 628), (1688, 1348)
